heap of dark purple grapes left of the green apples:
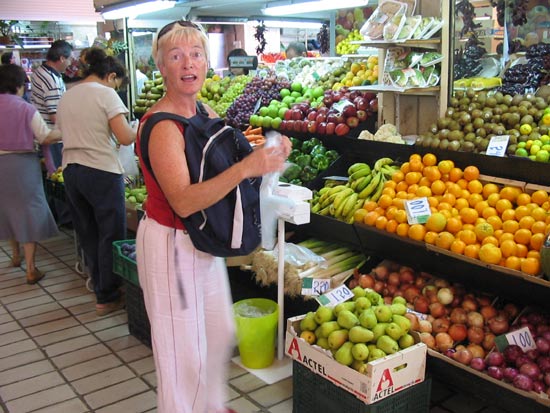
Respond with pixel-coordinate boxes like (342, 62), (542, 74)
(225, 73), (290, 129)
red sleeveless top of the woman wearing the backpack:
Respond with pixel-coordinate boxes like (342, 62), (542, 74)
(135, 113), (185, 230)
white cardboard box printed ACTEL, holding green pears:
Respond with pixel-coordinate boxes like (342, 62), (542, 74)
(285, 315), (427, 404)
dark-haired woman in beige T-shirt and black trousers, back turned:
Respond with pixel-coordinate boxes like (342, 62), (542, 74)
(57, 47), (136, 316)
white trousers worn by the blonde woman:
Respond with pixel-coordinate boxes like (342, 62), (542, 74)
(136, 217), (235, 413)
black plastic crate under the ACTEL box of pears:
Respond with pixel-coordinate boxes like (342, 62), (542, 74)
(292, 361), (431, 413)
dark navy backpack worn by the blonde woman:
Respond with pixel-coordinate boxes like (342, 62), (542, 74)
(140, 103), (261, 257)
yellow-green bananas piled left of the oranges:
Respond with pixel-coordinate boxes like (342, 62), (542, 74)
(311, 158), (398, 224)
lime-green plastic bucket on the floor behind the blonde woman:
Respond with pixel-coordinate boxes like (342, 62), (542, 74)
(233, 298), (279, 369)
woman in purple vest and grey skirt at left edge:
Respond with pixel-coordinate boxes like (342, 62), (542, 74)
(0, 64), (61, 284)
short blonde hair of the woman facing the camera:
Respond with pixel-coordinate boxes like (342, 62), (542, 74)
(152, 20), (210, 67)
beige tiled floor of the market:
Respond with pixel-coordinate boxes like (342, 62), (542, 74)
(0, 231), (516, 413)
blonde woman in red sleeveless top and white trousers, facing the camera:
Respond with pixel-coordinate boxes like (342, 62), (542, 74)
(136, 21), (290, 413)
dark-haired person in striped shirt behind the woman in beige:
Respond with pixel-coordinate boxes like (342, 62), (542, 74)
(31, 40), (73, 173)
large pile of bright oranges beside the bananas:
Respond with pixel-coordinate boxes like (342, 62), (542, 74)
(355, 153), (550, 275)
